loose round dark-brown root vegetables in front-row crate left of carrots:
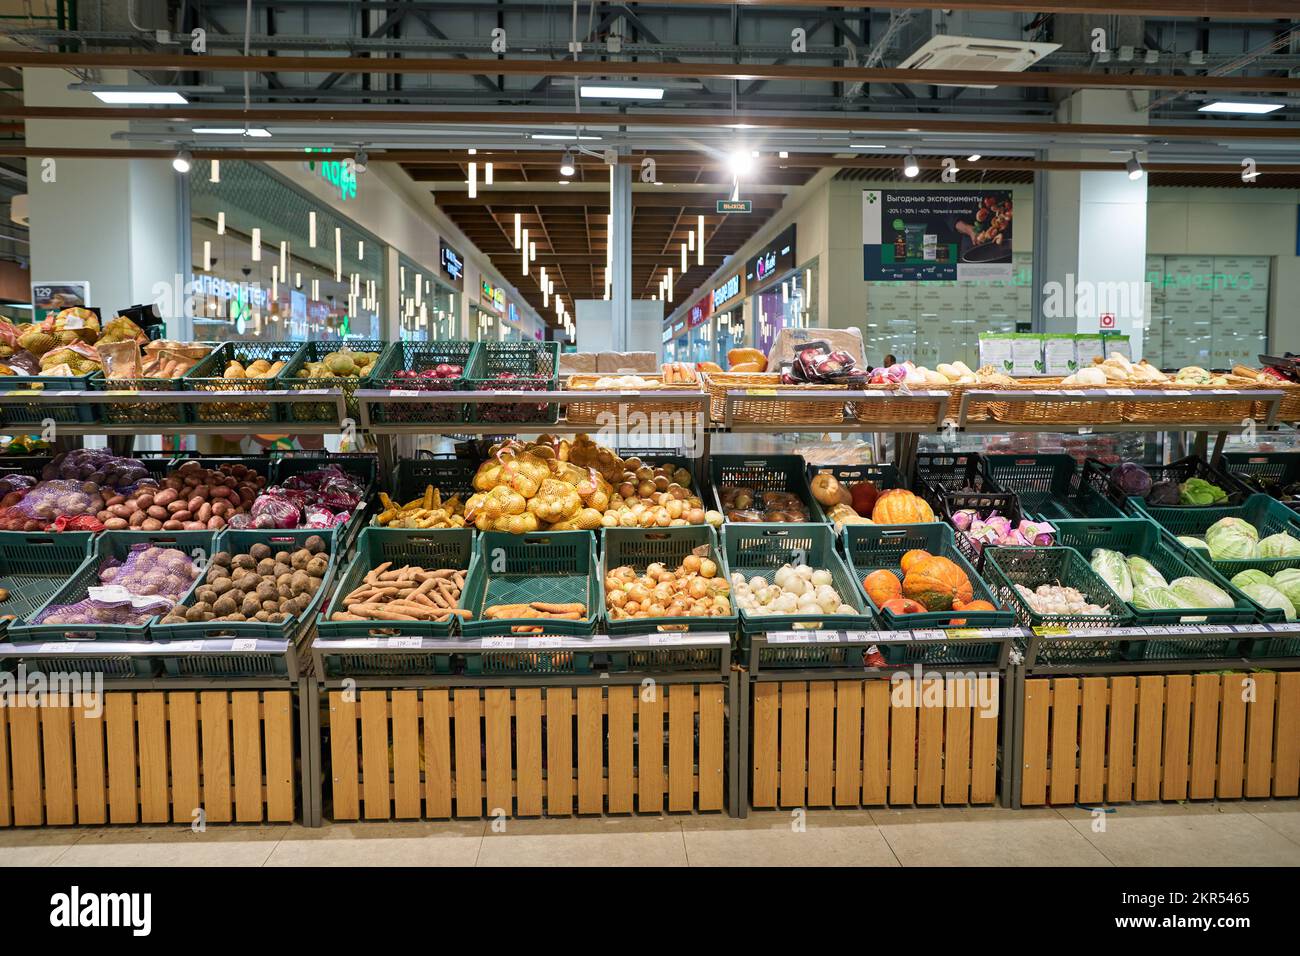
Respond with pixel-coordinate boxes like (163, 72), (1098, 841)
(163, 535), (329, 624)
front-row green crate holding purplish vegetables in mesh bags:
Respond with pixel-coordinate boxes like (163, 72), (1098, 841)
(9, 531), (216, 643)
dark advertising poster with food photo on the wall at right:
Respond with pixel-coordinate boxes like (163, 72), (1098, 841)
(862, 189), (1013, 282)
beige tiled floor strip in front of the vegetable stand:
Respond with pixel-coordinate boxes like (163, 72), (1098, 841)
(0, 800), (1300, 866)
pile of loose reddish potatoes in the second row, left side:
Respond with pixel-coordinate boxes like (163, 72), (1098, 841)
(98, 462), (267, 531)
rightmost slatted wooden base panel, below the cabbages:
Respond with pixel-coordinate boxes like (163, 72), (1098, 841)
(1021, 671), (1300, 805)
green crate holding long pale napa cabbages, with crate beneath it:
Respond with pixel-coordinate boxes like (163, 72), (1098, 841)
(1056, 518), (1257, 661)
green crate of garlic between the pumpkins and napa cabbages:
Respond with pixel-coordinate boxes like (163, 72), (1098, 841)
(984, 548), (1134, 663)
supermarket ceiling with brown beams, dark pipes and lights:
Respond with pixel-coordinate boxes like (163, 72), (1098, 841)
(0, 0), (1300, 321)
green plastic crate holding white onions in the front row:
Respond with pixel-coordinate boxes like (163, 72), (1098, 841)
(723, 523), (876, 633)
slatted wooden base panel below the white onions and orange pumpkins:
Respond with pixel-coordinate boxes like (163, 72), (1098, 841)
(750, 676), (1001, 808)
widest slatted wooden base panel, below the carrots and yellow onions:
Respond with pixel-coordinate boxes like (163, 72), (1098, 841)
(326, 683), (727, 819)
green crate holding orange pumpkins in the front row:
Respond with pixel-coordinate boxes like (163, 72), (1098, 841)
(840, 522), (1015, 631)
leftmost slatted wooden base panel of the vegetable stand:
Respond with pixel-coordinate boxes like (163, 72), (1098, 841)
(0, 691), (296, 826)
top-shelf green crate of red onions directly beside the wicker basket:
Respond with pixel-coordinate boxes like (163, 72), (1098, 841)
(465, 342), (560, 425)
